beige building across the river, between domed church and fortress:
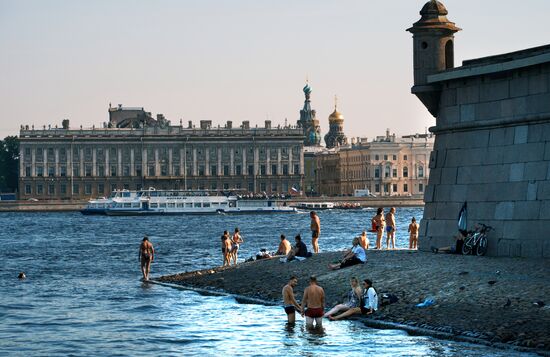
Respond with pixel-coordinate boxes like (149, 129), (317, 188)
(315, 130), (433, 196)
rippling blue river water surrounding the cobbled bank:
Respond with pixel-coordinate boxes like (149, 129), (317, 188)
(0, 208), (536, 356)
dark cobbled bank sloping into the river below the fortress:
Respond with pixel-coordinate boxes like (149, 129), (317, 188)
(157, 250), (550, 355)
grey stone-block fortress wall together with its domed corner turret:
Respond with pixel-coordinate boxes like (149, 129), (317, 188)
(408, 0), (550, 258)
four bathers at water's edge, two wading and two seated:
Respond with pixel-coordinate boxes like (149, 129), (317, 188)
(282, 276), (378, 328)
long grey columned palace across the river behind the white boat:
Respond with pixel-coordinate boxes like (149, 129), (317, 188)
(19, 106), (304, 199)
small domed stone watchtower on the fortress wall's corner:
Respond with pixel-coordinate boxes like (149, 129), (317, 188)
(407, 0), (460, 116)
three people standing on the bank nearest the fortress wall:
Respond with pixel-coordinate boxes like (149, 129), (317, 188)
(371, 207), (419, 249)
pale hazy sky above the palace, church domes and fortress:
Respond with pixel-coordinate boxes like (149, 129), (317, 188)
(0, 0), (550, 138)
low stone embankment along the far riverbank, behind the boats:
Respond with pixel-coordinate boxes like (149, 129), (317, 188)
(0, 196), (424, 212)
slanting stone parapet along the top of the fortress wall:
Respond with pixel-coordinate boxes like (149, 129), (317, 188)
(428, 45), (550, 83)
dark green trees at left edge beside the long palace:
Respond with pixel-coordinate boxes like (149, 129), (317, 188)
(0, 136), (19, 192)
